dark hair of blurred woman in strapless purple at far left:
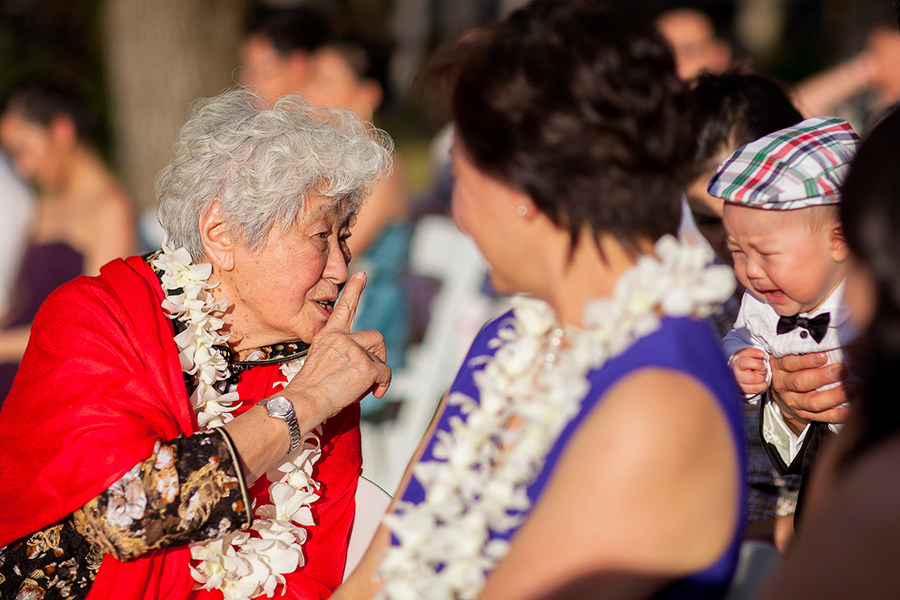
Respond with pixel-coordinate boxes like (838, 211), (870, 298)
(2, 79), (99, 143)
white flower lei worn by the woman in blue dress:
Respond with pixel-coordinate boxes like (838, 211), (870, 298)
(377, 236), (734, 600)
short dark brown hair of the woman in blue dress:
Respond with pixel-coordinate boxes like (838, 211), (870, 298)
(440, 0), (693, 252)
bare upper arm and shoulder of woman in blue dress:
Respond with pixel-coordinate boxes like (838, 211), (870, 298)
(474, 368), (740, 598)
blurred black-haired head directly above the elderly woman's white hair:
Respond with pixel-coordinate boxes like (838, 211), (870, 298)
(239, 7), (331, 105)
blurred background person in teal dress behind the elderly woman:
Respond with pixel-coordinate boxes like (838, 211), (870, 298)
(304, 37), (410, 417)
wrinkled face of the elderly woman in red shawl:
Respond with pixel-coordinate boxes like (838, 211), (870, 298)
(216, 196), (351, 352)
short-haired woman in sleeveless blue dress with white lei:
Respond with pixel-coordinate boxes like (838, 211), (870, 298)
(336, 0), (744, 599)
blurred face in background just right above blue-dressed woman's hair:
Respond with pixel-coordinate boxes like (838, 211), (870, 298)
(656, 8), (732, 81)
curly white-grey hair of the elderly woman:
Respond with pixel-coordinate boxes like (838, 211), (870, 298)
(156, 87), (393, 261)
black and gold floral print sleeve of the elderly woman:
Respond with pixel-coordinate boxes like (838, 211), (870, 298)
(0, 430), (252, 600)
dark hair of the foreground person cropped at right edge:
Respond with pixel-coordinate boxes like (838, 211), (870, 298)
(840, 109), (900, 458)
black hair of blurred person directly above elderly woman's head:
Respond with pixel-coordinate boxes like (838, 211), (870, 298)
(244, 6), (332, 55)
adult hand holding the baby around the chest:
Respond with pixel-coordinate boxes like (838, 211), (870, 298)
(770, 352), (850, 433)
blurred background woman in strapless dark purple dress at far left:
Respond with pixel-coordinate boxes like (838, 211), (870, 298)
(0, 80), (137, 399)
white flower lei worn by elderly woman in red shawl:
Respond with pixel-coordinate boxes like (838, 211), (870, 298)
(153, 243), (322, 600)
